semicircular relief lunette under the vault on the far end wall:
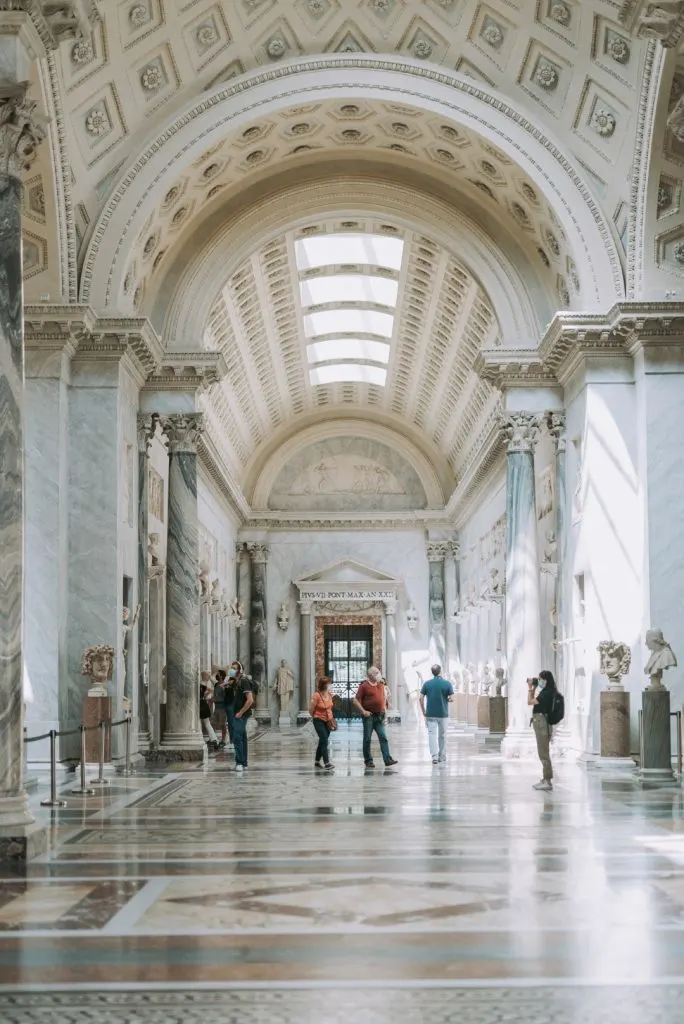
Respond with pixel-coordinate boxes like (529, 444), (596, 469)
(268, 437), (427, 511)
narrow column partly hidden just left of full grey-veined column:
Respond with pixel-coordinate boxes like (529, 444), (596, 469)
(137, 413), (158, 751)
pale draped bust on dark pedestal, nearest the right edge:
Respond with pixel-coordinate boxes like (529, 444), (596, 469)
(639, 629), (677, 782)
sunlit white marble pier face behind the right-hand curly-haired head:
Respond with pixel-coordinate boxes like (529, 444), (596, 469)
(560, 360), (643, 754)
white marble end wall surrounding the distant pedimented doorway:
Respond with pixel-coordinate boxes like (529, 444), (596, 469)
(259, 529), (430, 714)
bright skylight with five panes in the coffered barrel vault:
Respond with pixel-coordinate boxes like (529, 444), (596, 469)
(295, 233), (403, 387)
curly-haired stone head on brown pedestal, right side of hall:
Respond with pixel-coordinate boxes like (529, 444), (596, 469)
(596, 640), (634, 771)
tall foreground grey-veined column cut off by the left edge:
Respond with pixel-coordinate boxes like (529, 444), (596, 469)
(0, 94), (45, 858)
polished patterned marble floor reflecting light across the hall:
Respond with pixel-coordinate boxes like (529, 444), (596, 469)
(0, 724), (684, 1024)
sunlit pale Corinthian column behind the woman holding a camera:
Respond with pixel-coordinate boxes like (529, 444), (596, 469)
(502, 413), (542, 758)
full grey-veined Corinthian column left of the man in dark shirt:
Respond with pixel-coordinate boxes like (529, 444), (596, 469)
(157, 413), (206, 761)
